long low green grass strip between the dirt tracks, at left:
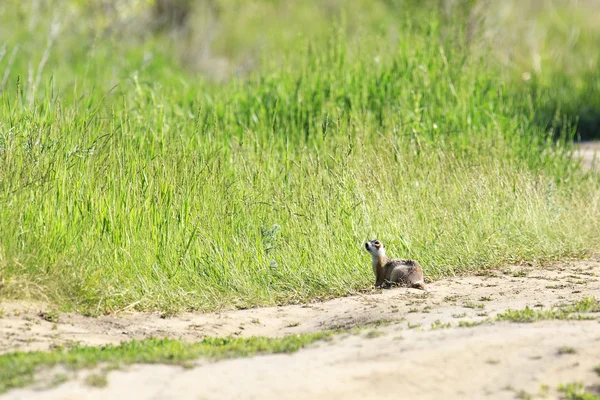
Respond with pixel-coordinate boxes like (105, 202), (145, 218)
(0, 332), (335, 393)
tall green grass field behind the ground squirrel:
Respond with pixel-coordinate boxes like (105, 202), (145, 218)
(0, 0), (600, 314)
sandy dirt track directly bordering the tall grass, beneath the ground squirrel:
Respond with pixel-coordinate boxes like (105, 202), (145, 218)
(0, 260), (600, 353)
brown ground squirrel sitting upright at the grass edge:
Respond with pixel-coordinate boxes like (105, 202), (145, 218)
(365, 240), (428, 292)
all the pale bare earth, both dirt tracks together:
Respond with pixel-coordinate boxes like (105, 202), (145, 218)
(0, 259), (600, 399)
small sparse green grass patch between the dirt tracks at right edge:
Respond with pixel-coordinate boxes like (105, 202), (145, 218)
(496, 297), (600, 322)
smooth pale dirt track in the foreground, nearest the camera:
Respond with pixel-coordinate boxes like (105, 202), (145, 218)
(3, 321), (600, 400)
